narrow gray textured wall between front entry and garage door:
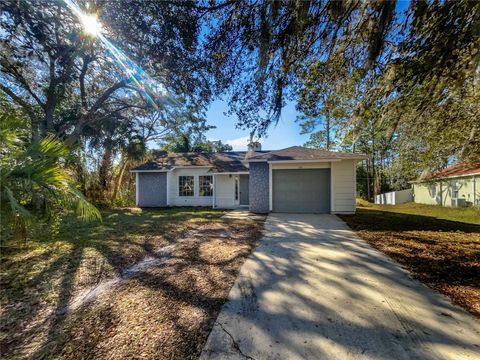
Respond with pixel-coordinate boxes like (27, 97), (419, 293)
(249, 162), (270, 213)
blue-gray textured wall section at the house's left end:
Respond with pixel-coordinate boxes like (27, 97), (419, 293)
(137, 172), (167, 207)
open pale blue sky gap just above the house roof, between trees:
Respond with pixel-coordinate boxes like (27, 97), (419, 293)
(206, 100), (309, 150)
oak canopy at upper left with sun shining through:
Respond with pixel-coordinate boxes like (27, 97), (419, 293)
(0, 0), (209, 145)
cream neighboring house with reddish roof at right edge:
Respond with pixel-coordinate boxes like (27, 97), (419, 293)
(412, 164), (480, 207)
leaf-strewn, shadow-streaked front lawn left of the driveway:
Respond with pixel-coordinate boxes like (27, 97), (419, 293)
(0, 208), (262, 359)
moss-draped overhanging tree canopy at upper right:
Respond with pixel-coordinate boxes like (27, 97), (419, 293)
(206, 0), (480, 166)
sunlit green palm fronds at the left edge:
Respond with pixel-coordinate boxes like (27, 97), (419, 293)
(0, 115), (101, 239)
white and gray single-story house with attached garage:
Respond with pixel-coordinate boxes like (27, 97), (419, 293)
(131, 146), (365, 213)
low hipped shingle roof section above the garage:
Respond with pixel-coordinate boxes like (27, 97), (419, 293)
(248, 146), (366, 161)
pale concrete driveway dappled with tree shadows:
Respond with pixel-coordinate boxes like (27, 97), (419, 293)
(201, 214), (480, 360)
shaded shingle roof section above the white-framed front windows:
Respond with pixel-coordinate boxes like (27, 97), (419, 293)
(132, 151), (248, 173)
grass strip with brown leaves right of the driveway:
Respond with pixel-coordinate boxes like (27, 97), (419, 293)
(340, 201), (480, 316)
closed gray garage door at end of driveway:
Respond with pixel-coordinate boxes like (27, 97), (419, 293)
(272, 169), (330, 213)
